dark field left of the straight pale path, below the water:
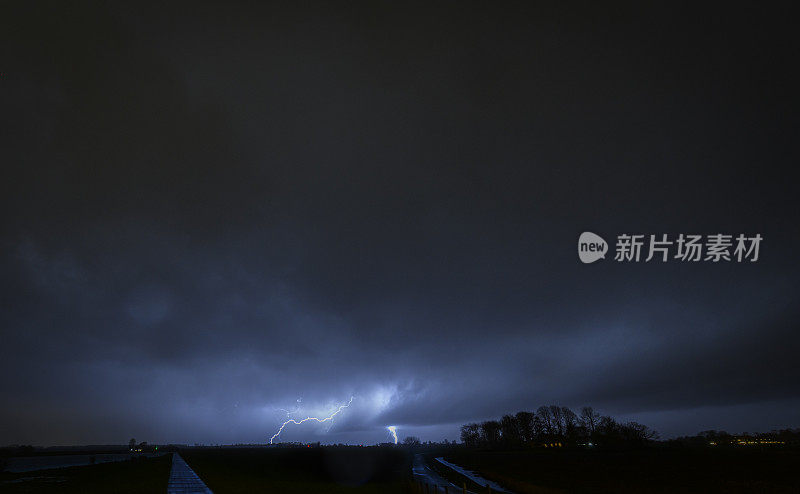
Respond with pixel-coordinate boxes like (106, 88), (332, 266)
(0, 455), (172, 493)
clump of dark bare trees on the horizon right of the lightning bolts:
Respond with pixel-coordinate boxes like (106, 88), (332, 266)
(461, 405), (658, 448)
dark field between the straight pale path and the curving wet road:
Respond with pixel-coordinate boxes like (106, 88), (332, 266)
(181, 447), (411, 494)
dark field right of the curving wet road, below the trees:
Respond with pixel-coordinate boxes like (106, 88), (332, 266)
(444, 448), (800, 494)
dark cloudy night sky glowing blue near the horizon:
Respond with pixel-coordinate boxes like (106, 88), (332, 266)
(0, 2), (800, 445)
